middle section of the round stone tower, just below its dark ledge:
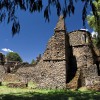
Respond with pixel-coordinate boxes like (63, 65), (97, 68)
(72, 45), (94, 68)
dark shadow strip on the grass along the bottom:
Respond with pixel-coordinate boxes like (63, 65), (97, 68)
(0, 91), (100, 100)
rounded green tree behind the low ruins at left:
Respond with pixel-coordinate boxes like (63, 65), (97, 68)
(6, 52), (22, 62)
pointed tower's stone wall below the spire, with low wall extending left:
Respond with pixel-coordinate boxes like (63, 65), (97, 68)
(16, 33), (66, 89)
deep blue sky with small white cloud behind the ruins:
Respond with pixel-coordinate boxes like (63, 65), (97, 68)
(0, 2), (92, 63)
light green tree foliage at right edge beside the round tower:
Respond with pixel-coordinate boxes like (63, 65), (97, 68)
(87, 0), (100, 48)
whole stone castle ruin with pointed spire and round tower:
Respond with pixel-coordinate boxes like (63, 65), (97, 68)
(0, 16), (100, 90)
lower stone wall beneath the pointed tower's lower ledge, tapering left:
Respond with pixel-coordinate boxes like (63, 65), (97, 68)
(16, 60), (66, 89)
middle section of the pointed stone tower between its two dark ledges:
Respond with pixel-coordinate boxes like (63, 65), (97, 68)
(43, 32), (65, 60)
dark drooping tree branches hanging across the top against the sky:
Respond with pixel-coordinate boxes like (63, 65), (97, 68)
(0, 0), (98, 35)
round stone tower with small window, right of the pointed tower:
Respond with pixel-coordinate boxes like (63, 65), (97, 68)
(68, 30), (98, 88)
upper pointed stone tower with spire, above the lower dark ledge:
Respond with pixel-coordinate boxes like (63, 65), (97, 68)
(43, 16), (66, 61)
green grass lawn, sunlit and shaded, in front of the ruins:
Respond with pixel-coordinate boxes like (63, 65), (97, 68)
(0, 84), (100, 100)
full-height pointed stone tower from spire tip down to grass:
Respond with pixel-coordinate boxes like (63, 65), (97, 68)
(36, 16), (68, 89)
